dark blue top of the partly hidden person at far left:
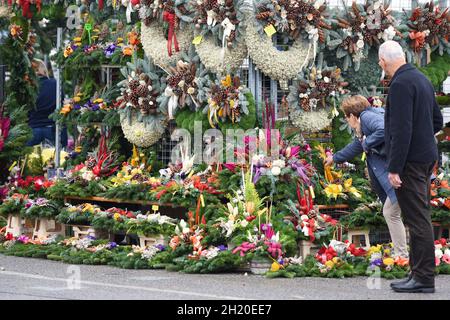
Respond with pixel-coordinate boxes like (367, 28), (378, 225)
(28, 77), (56, 128)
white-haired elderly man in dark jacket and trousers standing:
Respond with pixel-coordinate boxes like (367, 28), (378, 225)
(378, 41), (443, 293)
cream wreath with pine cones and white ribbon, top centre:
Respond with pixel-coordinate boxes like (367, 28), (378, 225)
(194, 0), (247, 73)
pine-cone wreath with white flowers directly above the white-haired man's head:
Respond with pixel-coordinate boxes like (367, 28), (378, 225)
(328, 0), (401, 71)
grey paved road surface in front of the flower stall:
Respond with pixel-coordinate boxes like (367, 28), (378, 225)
(0, 255), (450, 300)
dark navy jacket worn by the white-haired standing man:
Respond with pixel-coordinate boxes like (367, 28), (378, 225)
(384, 64), (443, 174)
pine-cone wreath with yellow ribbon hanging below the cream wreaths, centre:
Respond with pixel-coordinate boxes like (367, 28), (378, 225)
(203, 75), (250, 128)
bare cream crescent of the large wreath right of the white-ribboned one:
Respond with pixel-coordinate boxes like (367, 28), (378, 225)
(245, 18), (312, 80)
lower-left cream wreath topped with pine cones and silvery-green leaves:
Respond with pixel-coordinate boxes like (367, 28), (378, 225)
(117, 59), (166, 147)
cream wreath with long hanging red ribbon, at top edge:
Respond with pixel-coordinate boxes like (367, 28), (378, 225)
(139, 0), (193, 66)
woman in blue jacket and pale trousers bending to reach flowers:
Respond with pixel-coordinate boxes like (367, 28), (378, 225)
(325, 95), (408, 263)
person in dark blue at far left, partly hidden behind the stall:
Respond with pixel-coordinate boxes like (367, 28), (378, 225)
(27, 59), (67, 147)
